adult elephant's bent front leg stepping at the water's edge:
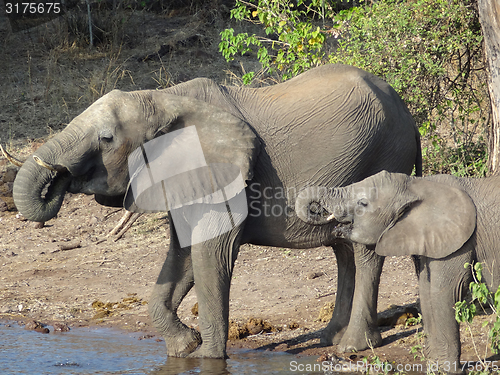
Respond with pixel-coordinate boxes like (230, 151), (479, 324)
(149, 224), (201, 357)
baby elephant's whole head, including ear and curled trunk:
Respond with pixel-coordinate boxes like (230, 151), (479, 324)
(295, 171), (476, 258)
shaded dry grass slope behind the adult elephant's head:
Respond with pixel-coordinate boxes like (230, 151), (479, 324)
(0, 2), (254, 154)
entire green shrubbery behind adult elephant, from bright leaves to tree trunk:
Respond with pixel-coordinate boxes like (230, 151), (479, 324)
(219, 0), (490, 176)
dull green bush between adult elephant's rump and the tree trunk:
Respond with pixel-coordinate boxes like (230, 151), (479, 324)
(329, 0), (489, 176)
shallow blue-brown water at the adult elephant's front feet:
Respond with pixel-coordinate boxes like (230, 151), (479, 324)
(0, 323), (323, 375)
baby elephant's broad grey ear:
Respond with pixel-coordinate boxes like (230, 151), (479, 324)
(375, 178), (476, 259)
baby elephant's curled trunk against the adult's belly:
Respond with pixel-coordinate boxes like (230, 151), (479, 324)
(295, 187), (349, 225)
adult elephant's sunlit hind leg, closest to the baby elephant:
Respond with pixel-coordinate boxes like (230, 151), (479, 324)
(339, 244), (384, 352)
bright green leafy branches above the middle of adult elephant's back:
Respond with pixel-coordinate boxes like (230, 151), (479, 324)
(219, 0), (331, 84)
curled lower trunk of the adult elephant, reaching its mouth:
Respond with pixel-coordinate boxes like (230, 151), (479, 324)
(13, 144), (71, 222)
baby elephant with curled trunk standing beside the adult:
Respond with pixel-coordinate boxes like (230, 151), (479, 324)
(295, 171), (500, 372)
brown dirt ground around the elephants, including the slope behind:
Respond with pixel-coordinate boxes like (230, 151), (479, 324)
(0, 2), (494, 374)
